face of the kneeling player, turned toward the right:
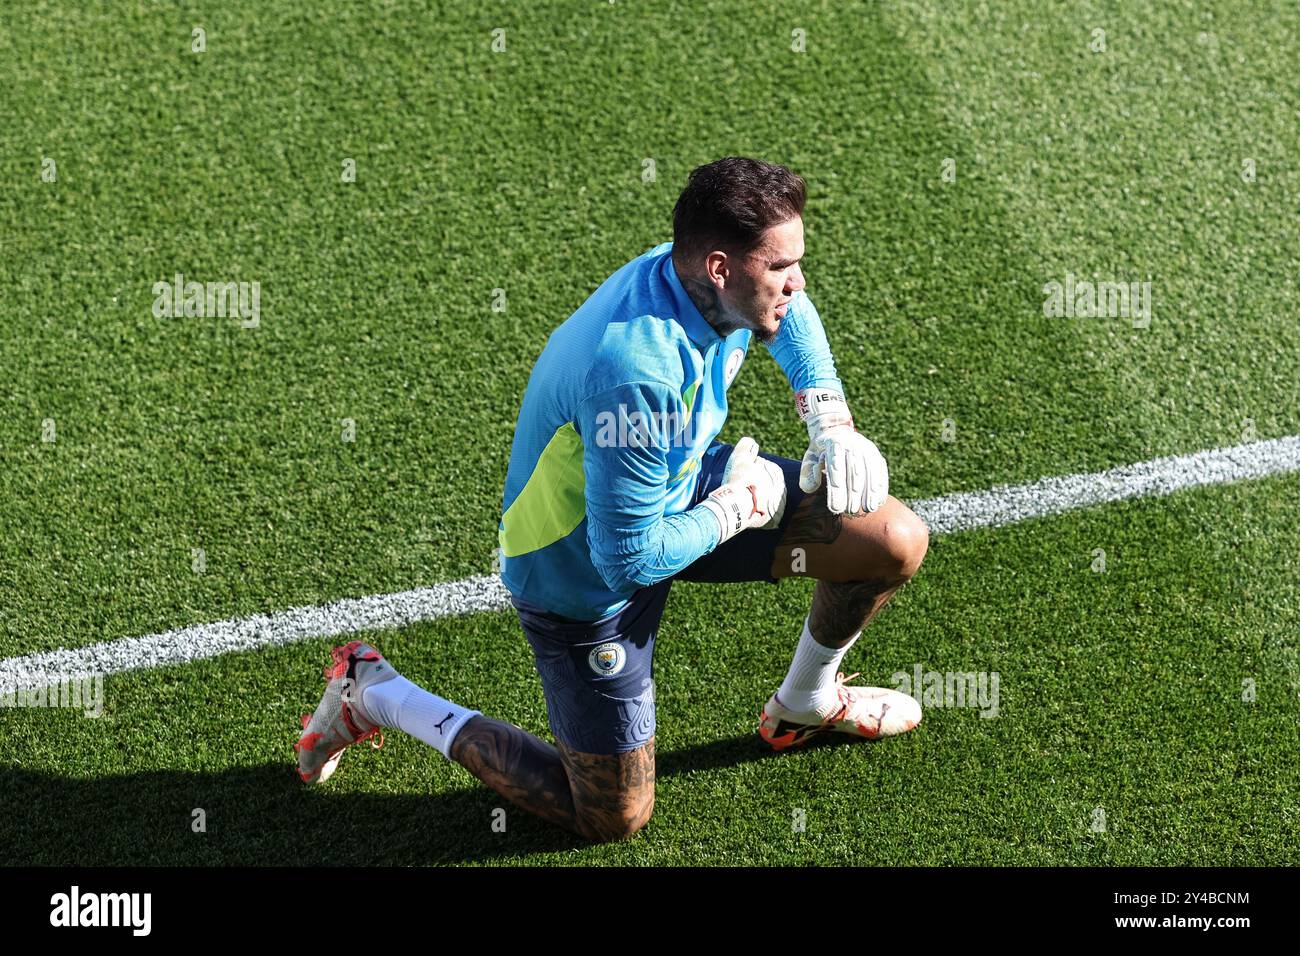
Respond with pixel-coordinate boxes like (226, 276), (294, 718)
(715, 216), (805, 343)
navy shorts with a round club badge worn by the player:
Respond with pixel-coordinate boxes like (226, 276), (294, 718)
(514, 442), (805, 754)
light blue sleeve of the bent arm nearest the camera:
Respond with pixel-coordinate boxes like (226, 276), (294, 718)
(576, 382), (720, 593)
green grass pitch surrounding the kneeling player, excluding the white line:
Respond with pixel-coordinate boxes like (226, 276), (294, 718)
(0, 0), (1300, 865)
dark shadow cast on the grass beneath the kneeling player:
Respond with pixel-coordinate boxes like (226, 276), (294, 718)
(0, 735), (854, 866)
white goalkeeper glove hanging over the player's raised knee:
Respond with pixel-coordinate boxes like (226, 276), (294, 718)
(794, 389), (889, 515)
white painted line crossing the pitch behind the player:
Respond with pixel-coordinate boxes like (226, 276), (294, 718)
(0, 436), (1300, 693)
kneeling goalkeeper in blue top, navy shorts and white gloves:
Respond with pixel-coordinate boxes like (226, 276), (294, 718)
(296, 156), (928, 840)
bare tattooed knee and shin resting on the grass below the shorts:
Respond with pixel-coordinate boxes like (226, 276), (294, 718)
(451, 714), (654, 840)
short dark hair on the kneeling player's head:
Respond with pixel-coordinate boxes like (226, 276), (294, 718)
(672, 156), (807, 264)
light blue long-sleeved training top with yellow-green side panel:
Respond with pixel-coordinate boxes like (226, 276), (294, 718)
(498, 242), (844, 620)
